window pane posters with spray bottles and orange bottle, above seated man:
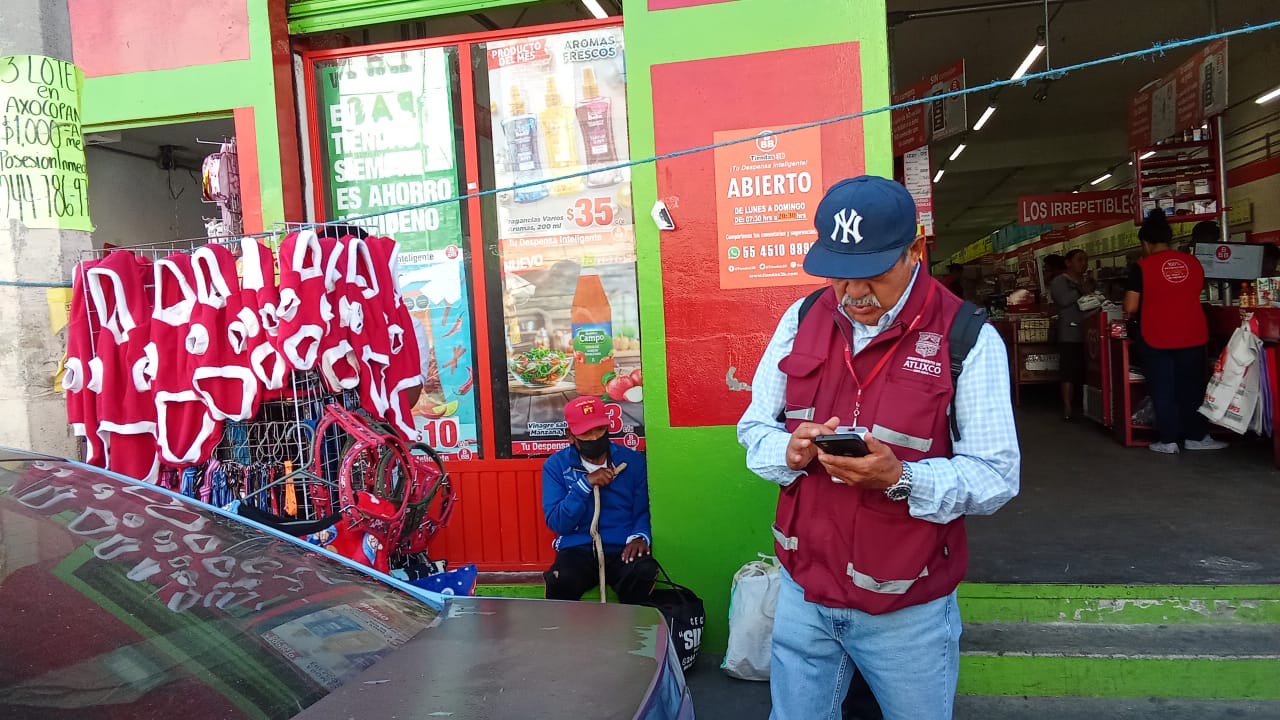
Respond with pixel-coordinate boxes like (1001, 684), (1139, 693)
(486, 27), (644, 455)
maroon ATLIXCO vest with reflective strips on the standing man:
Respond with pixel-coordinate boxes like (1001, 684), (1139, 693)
(773, 273), (969, 614)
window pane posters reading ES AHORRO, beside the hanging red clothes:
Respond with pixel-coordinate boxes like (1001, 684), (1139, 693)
(315, 47), (479, 460)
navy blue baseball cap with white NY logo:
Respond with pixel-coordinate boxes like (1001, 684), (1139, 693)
(804, 176), (916, 279)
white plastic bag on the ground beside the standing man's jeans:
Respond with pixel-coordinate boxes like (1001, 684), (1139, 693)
(721, 553), (782, 680)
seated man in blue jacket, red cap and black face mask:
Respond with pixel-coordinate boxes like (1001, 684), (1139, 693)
(543, 397), (658, 603)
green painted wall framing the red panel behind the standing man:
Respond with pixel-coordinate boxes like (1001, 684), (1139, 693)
(623, 0), (892, 652)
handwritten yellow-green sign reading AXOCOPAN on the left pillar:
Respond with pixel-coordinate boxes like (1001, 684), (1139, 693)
(0, 55), (93, 232)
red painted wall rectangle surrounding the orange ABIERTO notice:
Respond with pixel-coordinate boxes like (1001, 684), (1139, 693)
(646, 42), (865, 428)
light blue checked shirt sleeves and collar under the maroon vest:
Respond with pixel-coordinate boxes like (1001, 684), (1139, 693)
(737, 265), (1021, 523)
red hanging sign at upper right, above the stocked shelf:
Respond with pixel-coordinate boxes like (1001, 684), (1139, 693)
(1129, 40), (1228, 150)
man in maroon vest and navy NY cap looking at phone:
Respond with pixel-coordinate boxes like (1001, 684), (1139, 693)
(737, 176), (1020, 720)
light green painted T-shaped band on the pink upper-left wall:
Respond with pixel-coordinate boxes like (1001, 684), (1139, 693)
(82, 0), (284, 227)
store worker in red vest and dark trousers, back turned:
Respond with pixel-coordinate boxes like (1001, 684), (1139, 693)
(1124, 210), (1226, 455)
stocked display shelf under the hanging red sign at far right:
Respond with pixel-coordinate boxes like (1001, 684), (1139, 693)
(1133, 132), (1226, 223)
